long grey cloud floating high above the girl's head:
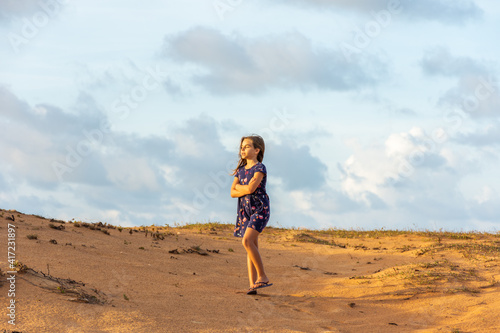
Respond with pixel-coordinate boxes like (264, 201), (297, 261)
(163, 27), (386, 94)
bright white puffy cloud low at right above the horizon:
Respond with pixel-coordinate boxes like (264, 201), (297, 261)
(339, 128), (499, 229)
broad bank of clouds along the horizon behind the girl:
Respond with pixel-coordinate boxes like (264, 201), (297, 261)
(0, 83), (498, 229)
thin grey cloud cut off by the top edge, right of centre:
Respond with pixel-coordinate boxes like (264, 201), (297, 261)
(276, 0), (483, 24)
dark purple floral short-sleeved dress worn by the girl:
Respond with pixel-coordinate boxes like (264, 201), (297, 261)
(234, 162), (271, 237)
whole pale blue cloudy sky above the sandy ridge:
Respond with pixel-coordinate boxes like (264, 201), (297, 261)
(0, 0), (500, 232)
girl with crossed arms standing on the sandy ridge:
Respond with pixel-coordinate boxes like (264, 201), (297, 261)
(231, 135), (272, 294)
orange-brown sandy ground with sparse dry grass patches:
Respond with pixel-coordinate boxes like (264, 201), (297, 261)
(0, 210), (500, 332)
